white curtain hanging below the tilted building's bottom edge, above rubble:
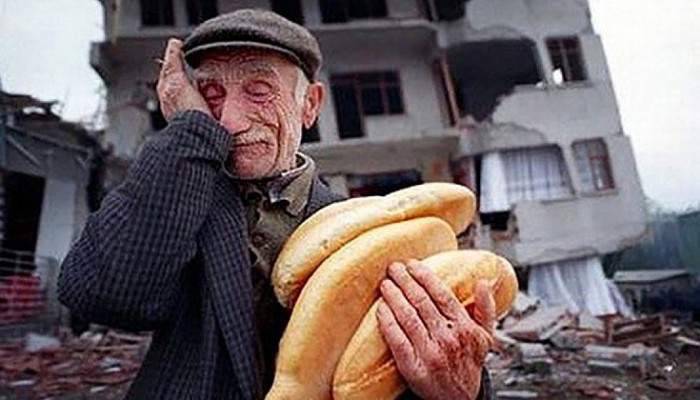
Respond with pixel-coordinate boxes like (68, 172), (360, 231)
(528, 257), (629, 315)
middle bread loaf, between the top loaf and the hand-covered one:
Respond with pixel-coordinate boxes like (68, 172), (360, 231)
(266, 217), (457, 400)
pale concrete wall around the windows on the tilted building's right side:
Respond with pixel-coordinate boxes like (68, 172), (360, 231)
(440, 0), (646, 265)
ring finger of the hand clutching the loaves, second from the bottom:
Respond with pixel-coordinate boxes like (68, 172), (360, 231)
(380, 279), (430, 348)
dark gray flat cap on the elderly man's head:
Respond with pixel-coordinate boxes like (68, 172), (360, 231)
(182, 9), (322, 81)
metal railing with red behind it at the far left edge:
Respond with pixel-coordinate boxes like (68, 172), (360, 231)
(0, 248), (60, 328)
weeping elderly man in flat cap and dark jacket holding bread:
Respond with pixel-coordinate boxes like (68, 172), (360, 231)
(59, 10), (494, 400)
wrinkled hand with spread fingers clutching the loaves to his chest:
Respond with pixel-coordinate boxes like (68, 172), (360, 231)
(377, 261), (496, 400)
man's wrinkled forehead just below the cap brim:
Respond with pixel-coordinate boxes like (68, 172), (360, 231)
(194, 48), (298, 83)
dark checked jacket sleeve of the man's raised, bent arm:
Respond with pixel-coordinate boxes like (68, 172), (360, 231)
(58, 111), (232, 330)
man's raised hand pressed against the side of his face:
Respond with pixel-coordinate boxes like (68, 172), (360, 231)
(156, 39), (211, 121)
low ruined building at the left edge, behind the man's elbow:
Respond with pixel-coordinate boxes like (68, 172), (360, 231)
(0, 88), (99, 335)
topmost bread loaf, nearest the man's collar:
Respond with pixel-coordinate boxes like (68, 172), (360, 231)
(271, 182), (476, 308)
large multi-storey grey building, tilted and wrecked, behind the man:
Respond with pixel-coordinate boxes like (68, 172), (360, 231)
(91, 0), (646, 314)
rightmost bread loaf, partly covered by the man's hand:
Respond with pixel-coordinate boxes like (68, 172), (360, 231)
(333, 250), (518, 400)
